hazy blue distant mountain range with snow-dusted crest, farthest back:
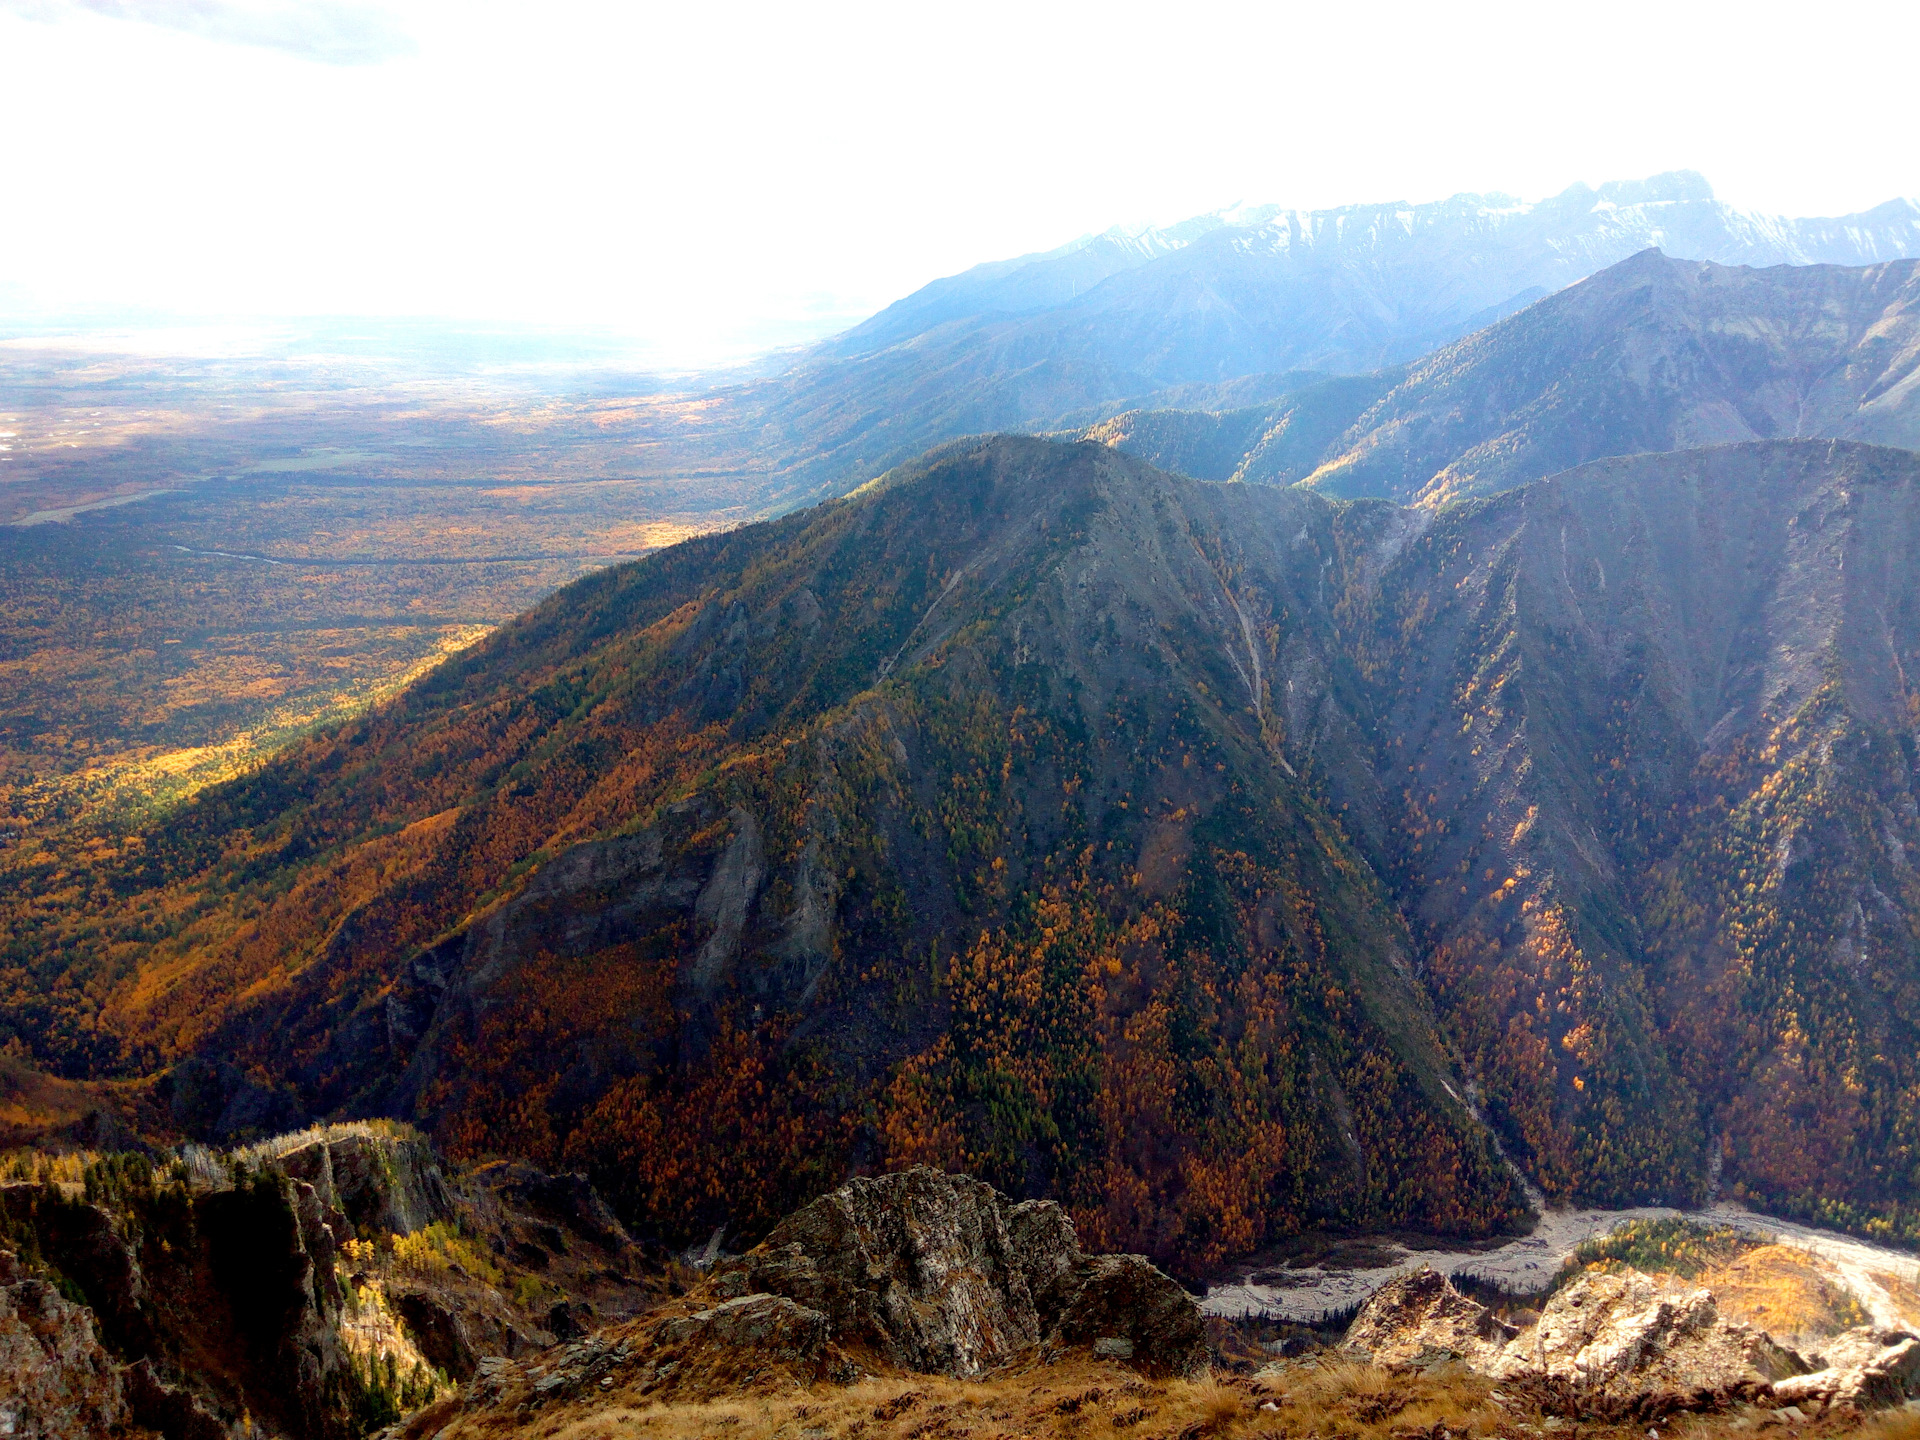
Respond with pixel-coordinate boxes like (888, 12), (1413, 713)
(641, 173), (1920, 511)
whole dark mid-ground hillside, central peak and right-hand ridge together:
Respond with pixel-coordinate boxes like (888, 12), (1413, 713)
(11, 438), (1920, 1265)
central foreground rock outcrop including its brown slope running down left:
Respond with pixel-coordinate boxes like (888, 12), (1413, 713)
(416, 1167), (1208, 1440)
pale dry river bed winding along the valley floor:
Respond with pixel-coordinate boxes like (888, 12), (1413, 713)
(1202, 1200), (1920, 1325)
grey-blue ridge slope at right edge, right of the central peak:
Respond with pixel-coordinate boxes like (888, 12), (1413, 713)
(1356, 442), (1920, 1236)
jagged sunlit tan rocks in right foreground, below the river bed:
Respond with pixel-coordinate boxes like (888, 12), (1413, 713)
(1344, 1269), (1807, 1396)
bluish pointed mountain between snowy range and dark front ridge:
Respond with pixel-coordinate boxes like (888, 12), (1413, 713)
(1083, 250), (1920, 505)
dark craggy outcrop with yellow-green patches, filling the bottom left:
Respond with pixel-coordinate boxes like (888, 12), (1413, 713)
(0, 1125), (666, 1440)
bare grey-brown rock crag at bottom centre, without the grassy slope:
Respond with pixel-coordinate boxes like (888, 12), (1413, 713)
(712, 1165), (1206, 1375)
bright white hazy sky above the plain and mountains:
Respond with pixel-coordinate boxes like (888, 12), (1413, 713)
(0, 0), (1920, 363)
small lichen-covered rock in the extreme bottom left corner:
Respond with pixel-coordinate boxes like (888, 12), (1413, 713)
(0, 1250), (127, 1440)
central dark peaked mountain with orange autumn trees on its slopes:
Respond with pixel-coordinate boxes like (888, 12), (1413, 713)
(8, 440), (1517, 1261)
